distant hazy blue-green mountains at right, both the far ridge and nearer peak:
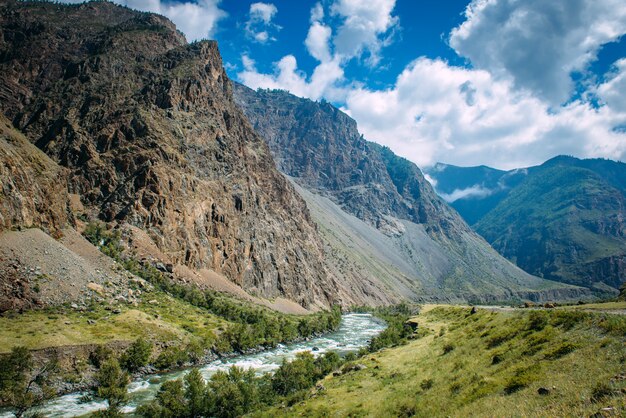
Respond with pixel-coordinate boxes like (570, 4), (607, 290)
(429, 156), (626, 292)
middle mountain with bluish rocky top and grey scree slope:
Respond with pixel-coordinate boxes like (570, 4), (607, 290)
(234, 84), (584, 301)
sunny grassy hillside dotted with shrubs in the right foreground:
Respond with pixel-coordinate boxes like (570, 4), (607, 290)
(259, 306), (626, 417)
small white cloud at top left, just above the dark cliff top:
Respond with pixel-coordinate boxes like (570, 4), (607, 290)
(60, 0), (227, 41)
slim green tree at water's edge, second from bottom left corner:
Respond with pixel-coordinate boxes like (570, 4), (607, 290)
(96, 358), (130, 418)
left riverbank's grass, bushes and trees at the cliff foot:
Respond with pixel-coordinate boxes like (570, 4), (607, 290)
(0, 223), (341, 417)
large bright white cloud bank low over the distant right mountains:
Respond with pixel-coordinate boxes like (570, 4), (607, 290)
(344, 58), (626, 169)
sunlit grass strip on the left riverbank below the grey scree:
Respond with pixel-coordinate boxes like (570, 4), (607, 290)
(0, 291), (231, 353)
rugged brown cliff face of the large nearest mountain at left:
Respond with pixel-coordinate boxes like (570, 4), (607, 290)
(0, 1), (352, 306)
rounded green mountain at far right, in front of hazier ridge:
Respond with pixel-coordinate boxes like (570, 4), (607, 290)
(475, 161), (626, 288)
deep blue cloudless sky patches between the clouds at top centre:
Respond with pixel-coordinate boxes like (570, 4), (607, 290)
(212, 0), (468, 91)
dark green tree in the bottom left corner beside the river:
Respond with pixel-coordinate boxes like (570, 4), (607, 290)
(0, 347), (57, 418)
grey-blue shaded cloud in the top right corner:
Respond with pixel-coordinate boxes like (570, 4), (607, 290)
(450, 0), (626, 105)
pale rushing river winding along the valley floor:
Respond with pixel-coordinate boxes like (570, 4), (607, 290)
(0, 314), (385, 418)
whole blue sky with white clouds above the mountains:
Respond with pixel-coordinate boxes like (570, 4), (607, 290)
(61, 0), (626, 169)
